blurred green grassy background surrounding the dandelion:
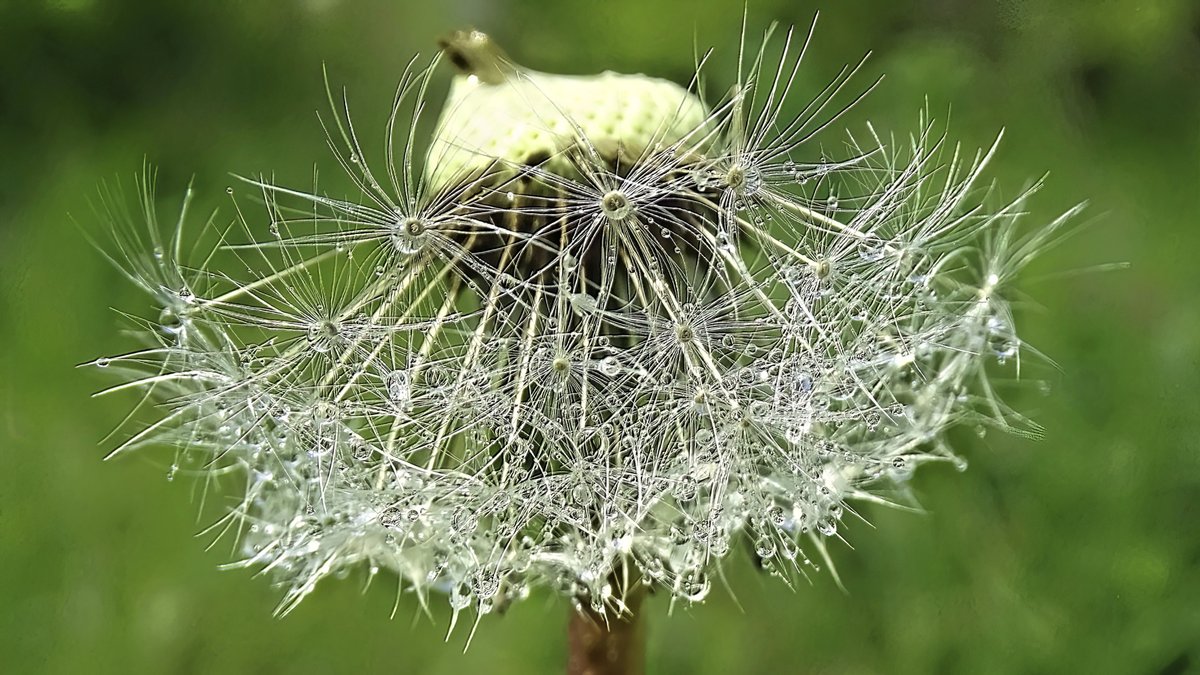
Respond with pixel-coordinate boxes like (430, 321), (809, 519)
(0, 0), (1200, 675)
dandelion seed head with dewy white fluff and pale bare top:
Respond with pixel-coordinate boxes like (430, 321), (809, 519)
(95, 26), (1069, 616)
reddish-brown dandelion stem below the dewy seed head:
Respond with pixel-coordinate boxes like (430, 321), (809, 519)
(566, 593), (646, 675)
